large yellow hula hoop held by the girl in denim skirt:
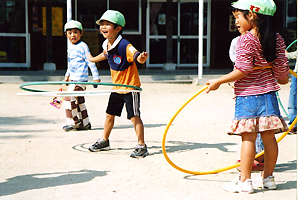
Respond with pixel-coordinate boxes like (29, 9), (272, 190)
(162, 85), (297, 175)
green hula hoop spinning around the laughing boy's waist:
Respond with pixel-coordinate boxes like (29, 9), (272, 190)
(19, 81), (142, 92)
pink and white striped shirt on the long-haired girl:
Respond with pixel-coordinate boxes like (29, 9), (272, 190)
(234, 32), (289, 96)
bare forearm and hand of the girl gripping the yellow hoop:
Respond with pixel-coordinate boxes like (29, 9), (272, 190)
(206, 69), (247, 93)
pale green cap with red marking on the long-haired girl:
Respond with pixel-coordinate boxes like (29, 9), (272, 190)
(232, 0), (276, 16)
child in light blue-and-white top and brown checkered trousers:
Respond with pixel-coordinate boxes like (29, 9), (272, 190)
(63, 20), (100, 132)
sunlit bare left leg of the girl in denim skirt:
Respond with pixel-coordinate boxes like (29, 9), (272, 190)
(241, 133), (257, 182)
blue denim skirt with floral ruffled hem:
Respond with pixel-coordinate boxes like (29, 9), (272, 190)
(228, 92), (288, 135)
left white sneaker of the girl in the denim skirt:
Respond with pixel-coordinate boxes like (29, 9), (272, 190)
(222, 176), (254, 194)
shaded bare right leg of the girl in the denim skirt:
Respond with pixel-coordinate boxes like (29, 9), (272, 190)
(261, 130), (278, 178)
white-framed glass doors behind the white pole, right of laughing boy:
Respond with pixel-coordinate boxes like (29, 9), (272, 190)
(146, 0), (211, 68)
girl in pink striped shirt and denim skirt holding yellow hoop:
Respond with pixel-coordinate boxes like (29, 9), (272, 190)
(206, 0), (289, 193)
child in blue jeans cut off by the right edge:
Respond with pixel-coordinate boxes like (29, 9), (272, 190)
(287, 50), (298, 134)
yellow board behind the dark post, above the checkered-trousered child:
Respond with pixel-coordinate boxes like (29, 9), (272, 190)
(42, 7), (63, 36)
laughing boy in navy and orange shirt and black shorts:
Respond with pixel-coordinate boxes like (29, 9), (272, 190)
(89, 10), (149, 158)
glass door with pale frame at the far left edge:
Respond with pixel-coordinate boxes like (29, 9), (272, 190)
(0, 0), (30, 68)
